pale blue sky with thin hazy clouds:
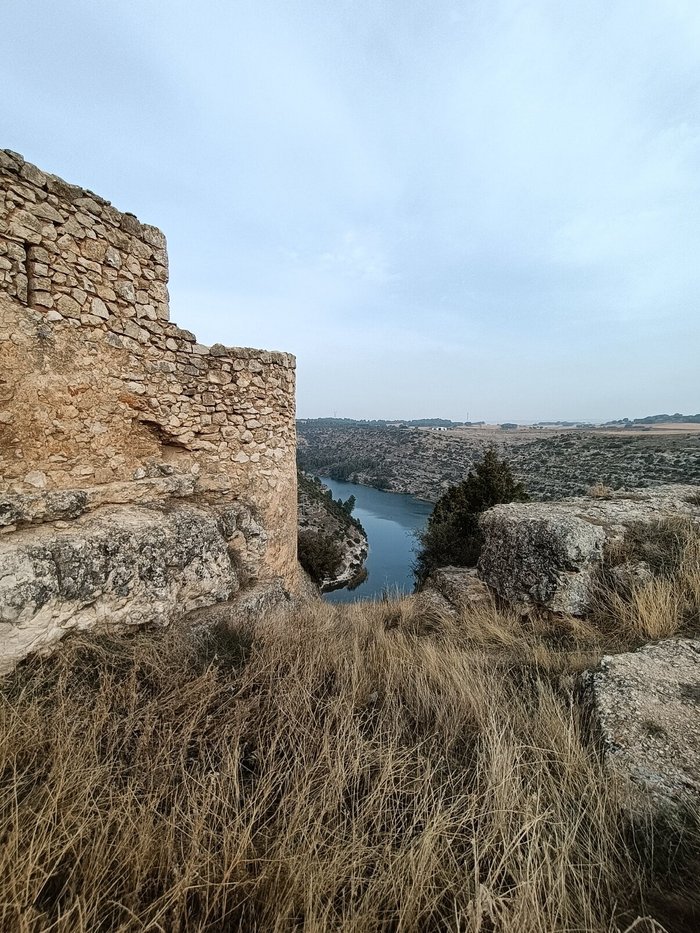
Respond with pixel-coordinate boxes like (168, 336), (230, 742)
(0, 0), (700, 422)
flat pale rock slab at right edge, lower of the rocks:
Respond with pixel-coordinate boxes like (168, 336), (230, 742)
(583, 639), (700, 808)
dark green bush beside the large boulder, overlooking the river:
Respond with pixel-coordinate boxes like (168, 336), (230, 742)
(413, 447), (529, 584)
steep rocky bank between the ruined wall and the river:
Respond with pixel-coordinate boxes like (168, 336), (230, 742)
(297, 472), (368, 592)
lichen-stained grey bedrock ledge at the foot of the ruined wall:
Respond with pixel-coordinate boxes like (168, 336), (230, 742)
(0, 501), (266, 672)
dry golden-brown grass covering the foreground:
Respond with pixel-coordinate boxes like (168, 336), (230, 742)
(0, 520), (700, 933)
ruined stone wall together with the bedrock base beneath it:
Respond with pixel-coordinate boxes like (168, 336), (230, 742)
(0, 151), (297, 659)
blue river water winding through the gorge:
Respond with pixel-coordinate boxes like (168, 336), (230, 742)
(321, 476), (433, 603)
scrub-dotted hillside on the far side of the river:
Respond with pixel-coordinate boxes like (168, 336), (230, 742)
(298, 421), (700, 501)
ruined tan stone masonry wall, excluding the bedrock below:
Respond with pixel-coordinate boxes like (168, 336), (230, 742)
(0, 151), (297, 668)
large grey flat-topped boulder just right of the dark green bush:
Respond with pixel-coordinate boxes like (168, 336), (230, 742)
(479, 485), (700, 615)
